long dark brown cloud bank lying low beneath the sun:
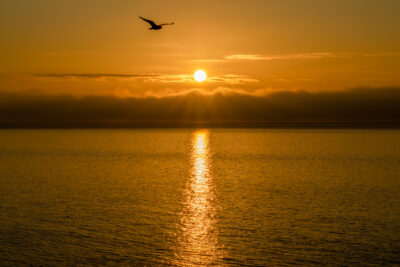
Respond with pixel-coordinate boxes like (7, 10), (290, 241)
(0, 87), (400, 126)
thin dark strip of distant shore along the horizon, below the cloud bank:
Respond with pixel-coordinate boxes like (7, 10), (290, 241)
(0, 122), (400, 129)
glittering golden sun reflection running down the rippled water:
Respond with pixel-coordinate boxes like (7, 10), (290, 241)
(177, 130), (222, 266)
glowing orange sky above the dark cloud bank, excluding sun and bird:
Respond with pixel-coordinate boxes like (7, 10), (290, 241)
(0, 0), (400, 123)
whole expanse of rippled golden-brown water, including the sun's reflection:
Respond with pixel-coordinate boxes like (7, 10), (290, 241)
(0, 129), (400, 266)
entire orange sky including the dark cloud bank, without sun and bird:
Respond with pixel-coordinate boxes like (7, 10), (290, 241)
(0, 0), (400, 123)
